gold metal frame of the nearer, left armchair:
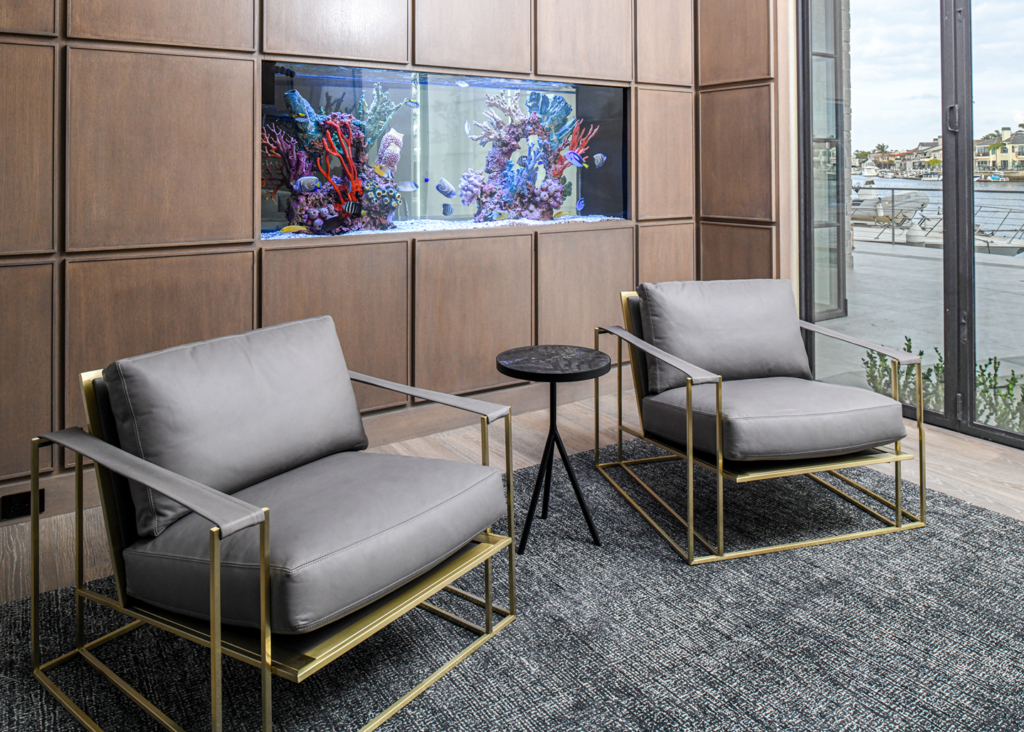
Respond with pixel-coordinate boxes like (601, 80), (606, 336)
(31, 371), (516, 732)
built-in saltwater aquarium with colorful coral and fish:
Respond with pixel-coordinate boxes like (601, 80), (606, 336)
(260, 61), (628, 239)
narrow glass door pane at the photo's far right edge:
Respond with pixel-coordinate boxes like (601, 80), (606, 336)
(961, 0), (1024, 443)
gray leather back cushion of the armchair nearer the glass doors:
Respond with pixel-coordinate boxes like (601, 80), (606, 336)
(637, 279), (811, 394)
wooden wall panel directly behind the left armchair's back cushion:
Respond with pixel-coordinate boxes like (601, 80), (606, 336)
(65, 252), (254, 427)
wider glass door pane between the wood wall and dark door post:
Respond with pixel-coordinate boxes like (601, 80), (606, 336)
(802, 0), (947, 416)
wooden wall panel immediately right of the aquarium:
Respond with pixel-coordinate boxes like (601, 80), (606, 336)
(637, 89), (694, 220)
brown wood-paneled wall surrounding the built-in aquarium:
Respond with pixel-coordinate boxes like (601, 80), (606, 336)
(0, 0), (792, 501)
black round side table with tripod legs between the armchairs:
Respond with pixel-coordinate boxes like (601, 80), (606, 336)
(496, 346), (611, 554)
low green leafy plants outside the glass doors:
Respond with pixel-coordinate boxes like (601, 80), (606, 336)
(860, 337), (1024, 433)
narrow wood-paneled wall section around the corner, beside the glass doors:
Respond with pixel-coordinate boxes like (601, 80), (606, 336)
(695, 0), (796, 279)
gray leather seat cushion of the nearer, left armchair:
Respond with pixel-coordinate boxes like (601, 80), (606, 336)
(124, 453), (506, 634)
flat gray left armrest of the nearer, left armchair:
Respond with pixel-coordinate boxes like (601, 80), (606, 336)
(40, 427), (263, 536)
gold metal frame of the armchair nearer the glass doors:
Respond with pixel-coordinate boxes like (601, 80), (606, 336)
(594, 292), (927, 565)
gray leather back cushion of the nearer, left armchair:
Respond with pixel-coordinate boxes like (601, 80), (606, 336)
(103, 316), (367, 536)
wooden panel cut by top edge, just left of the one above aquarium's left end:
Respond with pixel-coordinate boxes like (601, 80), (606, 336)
(68, 0), (256, 51)
